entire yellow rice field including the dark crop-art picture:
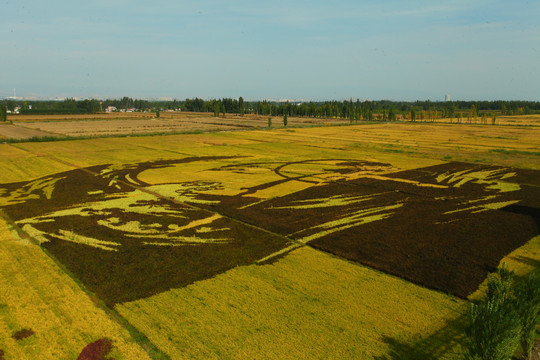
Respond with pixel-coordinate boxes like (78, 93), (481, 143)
(0, 120), (540, 360)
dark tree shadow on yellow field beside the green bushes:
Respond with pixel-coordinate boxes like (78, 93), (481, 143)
(375, 315), (467, 360)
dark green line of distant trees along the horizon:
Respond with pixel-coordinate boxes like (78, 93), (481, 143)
(0, 97), (540, 122)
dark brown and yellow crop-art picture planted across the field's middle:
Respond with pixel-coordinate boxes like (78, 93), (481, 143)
(0, 156), (540, 305)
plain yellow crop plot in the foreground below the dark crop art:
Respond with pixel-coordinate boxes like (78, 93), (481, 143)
(116, 247), (467, 359)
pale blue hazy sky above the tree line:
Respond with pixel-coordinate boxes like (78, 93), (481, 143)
(0, 0), (540, 101)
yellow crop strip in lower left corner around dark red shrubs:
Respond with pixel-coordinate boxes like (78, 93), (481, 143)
(0, 219), (149, 360)
